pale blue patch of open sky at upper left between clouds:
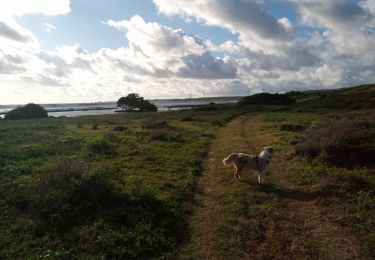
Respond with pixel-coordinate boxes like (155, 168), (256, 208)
(17, 0), (241, 51)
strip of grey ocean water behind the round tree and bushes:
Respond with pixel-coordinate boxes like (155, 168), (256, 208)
(0, 97), (240, 118)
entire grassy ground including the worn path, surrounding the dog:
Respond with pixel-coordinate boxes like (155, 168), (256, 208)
(0, 85), (375, 259)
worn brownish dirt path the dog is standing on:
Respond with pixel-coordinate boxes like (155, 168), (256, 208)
(180, 116), (359, 259)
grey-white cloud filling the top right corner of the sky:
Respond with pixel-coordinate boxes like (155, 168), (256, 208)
(293, 0), (375, 55)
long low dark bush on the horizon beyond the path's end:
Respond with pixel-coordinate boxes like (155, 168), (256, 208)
(238, 93), (296, 105)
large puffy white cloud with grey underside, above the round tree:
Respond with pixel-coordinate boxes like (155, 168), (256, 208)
(106, 16), (236, 79)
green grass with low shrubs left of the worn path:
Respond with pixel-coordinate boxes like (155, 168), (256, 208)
(0, 107), (244, 259)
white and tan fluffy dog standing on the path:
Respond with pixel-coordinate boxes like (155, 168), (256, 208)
(223, 146), (273, 184)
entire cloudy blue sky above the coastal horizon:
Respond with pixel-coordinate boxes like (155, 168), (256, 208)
(0, 0), (375, 104)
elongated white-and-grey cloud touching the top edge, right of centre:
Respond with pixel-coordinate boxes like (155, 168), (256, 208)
(154, 0), (289, 39)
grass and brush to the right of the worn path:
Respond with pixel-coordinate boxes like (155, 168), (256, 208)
(262, 110), (375, 257)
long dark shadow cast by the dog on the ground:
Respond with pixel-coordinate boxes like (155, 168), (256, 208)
(241, 180), (318, 202)
